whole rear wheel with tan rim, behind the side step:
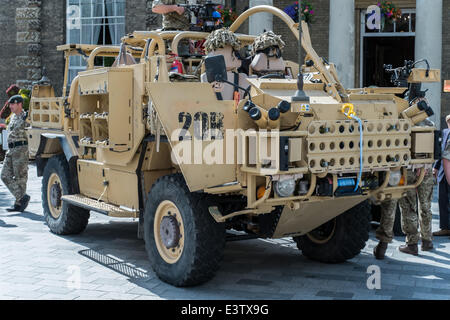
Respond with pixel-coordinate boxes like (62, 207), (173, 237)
(42, 155), (90, 235)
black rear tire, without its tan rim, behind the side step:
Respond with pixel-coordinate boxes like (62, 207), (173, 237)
(42, 155), (90, 235)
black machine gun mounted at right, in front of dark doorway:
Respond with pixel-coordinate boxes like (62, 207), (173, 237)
(383, 59), (430, 103)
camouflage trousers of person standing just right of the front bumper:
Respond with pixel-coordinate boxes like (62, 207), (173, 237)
(399, 170), (434, 244)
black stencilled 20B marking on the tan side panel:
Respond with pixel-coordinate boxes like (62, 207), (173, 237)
(178, 112), (224, 141)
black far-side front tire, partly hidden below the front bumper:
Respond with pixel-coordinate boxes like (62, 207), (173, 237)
(294, 201), (371, 263)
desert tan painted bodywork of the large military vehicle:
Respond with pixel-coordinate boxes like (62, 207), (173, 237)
(30, 6), (440, 236)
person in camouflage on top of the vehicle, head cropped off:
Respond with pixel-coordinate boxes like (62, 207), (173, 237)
(152, 0), (190, 31)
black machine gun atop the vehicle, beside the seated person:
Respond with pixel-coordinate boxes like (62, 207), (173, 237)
(178, 0), (223, 32)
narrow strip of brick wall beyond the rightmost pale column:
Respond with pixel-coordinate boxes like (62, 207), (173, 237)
(441, 0), (450, 128)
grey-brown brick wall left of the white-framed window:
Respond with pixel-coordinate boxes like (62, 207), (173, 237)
(0, 0), (66, 102)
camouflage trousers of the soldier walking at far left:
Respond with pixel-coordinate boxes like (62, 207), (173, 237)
(1, 146), (28, 204)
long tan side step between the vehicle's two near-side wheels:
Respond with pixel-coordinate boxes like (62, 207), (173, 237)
(61, 194), (139, 218)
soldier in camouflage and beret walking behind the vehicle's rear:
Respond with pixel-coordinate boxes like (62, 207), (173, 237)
(1, 95), (30, 212)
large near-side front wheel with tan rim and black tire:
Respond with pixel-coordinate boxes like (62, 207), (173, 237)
(144, 174), (225, 287)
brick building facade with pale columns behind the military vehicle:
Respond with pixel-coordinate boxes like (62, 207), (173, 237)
(0, 0), (450, 124)
